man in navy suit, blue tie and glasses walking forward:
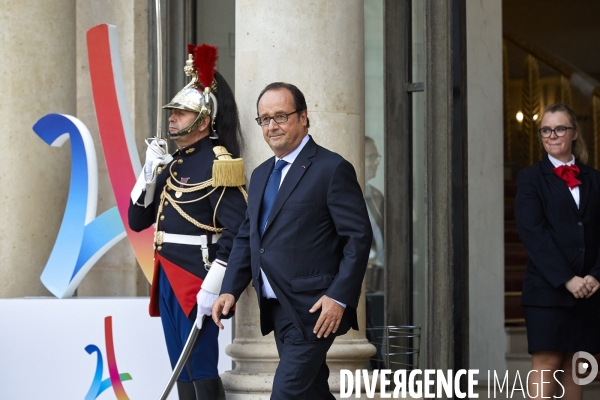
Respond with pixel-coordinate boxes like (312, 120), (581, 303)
(213, 82), (372, 400)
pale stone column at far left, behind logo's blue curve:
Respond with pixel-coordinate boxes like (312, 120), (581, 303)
(0, 0), (76, 298)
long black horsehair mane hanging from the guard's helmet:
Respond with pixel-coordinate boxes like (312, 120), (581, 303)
(213, 72), (243, 158)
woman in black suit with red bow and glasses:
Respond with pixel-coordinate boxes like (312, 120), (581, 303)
(515, 103), (600, 399)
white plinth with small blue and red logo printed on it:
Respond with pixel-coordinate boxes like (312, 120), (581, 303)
(0, 297), (232, 400)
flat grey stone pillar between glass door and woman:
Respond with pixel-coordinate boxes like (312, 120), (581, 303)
(466, 0), (507, 384)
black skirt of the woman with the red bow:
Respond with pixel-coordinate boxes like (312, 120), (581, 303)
(523, 300), (600, 354)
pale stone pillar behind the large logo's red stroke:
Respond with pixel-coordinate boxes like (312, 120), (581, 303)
(76, 0), (150, 296)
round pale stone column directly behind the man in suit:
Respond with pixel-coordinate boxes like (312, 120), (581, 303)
(222, 0), (375, 400)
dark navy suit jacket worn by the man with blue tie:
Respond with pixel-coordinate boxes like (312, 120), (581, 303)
(221, 138), (372, 340)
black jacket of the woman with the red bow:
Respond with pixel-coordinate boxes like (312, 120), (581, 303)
(515, 156), (600, 306)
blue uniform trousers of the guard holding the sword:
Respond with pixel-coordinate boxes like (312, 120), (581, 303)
(158, 266), (219, 382)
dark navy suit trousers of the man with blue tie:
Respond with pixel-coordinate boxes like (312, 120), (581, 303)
(261, 298), (335, 400)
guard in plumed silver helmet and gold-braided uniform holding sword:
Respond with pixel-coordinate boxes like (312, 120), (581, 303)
(129, 44), (247, 400)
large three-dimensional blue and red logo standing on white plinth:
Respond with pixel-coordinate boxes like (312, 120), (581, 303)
(33, 24), (153, 298)
